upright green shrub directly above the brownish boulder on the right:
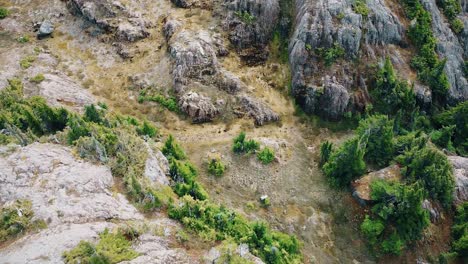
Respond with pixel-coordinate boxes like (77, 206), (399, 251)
(356, 115), (393, 167)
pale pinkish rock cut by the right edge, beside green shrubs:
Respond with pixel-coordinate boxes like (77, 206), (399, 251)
(448, 156), (468, 204)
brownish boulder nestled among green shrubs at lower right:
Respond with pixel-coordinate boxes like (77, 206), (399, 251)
(351, 165), (402, 205)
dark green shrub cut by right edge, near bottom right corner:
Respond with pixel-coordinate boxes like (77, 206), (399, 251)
(452, 202), (468, 258)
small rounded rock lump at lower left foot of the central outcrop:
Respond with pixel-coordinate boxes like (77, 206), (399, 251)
(179, 92), (219, 123)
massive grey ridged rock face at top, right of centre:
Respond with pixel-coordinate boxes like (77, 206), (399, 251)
(289, 0), (405, 119)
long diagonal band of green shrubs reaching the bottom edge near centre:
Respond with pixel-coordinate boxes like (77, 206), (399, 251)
(168, 196), (302, 263)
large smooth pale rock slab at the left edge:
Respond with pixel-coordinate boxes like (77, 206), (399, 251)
(0, 143), (143, 226)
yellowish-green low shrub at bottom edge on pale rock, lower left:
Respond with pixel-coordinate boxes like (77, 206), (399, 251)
(62, 229), (139, 264)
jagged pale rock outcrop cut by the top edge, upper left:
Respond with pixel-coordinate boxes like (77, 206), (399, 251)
(67, 0), (149, 42)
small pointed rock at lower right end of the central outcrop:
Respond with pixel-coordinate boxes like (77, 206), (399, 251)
(239, 95), (279, 126)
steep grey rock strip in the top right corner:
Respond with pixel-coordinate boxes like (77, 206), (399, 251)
(421, 0), (468, 104)
